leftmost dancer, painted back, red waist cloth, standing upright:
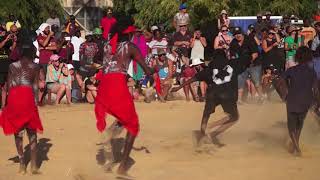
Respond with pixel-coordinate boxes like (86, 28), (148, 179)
(0, 43), (43, 174)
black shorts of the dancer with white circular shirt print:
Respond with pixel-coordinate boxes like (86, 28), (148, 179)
(203, 89), (238, 116)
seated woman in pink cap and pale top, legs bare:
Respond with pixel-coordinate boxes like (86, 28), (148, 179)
(46, 54), (66, 105)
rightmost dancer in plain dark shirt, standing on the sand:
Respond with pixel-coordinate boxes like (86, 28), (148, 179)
(281, 46), (317, 156)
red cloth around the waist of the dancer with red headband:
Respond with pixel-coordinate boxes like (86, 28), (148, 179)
(95, 73), (139, 136)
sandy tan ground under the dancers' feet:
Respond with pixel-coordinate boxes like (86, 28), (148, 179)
(0, 98), (320, 180)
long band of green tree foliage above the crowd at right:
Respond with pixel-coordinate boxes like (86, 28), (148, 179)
(114, 0), (317, 30)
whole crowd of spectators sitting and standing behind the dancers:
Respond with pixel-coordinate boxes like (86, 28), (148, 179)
(0, 3), (320, 106)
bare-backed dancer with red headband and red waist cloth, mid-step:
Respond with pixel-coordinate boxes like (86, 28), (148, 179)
(95, 19), (152, 175)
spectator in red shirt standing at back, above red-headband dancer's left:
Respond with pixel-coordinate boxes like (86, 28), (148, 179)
(100, 7), (117, 40)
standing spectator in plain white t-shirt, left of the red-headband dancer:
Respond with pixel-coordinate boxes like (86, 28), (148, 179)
(71, 30), (85, 71)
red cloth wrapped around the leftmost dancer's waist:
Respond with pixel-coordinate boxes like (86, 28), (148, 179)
(0, 86), (43, 135)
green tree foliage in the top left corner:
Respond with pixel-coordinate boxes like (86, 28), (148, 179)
(0, 0), (63, 29)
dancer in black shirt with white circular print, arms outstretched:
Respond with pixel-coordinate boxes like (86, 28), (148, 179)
(171, 49), (250, 145)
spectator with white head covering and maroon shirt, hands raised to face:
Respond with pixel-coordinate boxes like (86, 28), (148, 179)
(37, 23), (57, 71)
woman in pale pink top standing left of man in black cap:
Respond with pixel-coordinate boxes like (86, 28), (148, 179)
(213, 25), (232, 59)
